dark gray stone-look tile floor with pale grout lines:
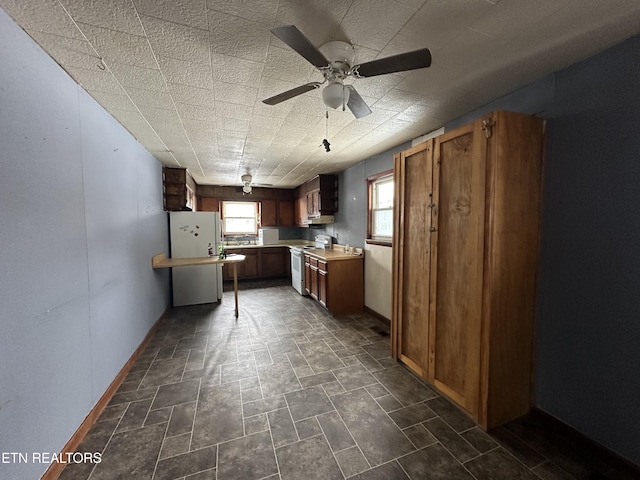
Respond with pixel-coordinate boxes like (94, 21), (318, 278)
(60, 282), (632, 480)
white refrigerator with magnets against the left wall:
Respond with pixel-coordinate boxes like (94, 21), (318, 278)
(169, 212), (222, 307)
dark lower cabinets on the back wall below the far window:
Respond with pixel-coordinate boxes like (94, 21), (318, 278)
(222, 247), (291, 280)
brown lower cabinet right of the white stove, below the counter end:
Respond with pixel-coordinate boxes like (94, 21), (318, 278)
(304, 254), (364, 315)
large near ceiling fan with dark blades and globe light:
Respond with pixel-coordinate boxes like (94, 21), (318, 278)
(263, 25), (431, 118)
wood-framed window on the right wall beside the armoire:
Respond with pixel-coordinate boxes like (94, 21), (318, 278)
(367, 170), (393, 245)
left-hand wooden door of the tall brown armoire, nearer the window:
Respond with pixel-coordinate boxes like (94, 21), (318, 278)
(392, 140), (433, 378)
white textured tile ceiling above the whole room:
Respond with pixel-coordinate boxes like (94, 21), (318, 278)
(0, 0), (640, 188)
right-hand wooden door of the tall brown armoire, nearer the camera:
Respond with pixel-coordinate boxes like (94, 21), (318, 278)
(427, 122), (486, 415)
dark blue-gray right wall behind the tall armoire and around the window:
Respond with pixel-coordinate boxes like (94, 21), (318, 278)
(334, 36), (640, 464)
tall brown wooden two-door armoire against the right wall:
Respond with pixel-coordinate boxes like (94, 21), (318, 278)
(392, 111), (544, 429)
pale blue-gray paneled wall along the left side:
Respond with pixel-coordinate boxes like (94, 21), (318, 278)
(0, 10), (169, 479)
